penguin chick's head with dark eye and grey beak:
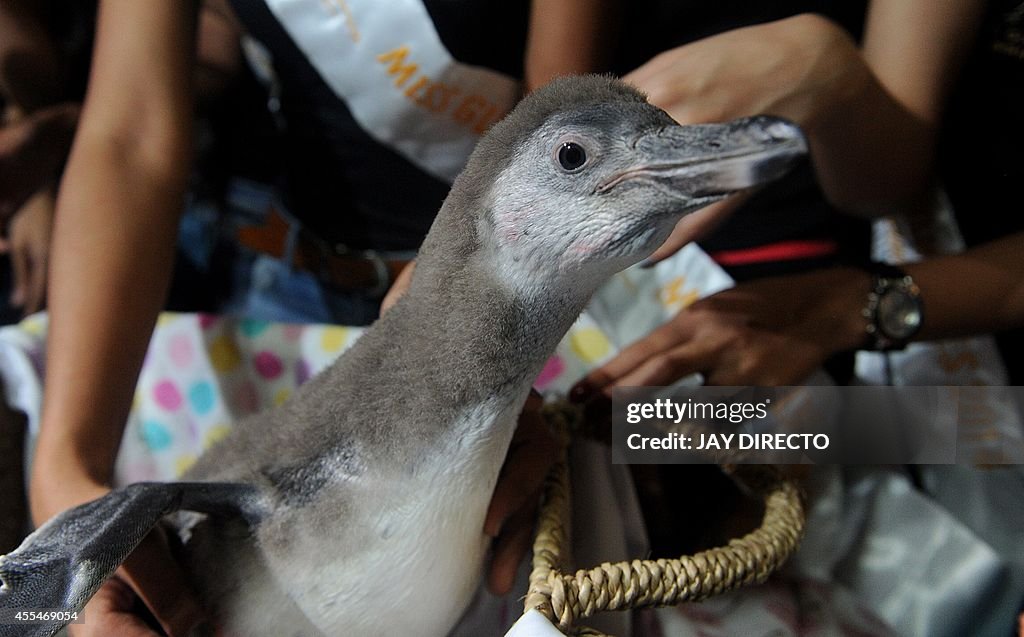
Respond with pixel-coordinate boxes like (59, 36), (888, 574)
(419, 76), (807, 299)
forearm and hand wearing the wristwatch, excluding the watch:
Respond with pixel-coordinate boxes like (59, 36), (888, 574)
(575, 232), (1024, 391)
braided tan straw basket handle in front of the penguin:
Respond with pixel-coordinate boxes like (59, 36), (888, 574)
(524, 407), (804, 635)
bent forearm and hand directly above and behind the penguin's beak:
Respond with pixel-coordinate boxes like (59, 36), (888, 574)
(624, 14), (934, 216)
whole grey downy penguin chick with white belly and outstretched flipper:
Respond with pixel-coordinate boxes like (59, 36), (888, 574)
(0, 76), (806, 637)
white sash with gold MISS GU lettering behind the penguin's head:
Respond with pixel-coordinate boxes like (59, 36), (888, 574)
(265, 0), (521, 182)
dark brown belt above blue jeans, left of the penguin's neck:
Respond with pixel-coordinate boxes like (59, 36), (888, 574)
(238, 208), (410, 297)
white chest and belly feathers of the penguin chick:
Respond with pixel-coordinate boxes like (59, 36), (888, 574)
(202, 400), (520, 637)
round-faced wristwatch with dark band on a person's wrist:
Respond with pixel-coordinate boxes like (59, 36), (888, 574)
(861, 262), (925, 351)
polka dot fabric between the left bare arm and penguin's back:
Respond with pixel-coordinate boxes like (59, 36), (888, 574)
(117, 314), (361, 482)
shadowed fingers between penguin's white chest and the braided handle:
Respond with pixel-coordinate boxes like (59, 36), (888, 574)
(483, 392), (559, 595)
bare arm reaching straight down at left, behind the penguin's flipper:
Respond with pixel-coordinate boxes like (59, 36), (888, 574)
(30, 0), (205, 634)
